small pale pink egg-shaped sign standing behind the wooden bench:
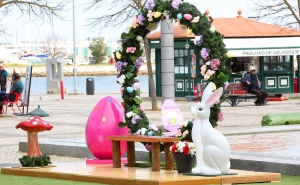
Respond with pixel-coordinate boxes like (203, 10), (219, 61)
(161, 99), (183, 132)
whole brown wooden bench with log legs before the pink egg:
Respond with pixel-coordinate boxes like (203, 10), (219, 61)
(107, 134), (178, 171)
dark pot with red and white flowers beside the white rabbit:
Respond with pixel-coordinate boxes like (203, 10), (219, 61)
(170, 141), (196, 173)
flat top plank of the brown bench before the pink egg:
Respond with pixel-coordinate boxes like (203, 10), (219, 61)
(107, 134), (178, 143)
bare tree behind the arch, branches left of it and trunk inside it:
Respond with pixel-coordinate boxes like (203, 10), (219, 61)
(86, 0), (158, 111)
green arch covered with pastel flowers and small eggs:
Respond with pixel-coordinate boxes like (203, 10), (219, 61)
(114, 0), (228, 135)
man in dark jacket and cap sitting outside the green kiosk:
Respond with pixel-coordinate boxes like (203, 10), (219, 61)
(240, 66), (269, 106)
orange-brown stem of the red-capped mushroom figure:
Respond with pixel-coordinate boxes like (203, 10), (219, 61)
(27, 132), (42, 157)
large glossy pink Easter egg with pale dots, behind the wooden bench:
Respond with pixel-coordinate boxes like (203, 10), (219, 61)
(85, 96), (128, 159)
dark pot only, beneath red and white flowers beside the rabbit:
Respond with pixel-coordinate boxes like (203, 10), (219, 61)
(173, 153), (195, 173)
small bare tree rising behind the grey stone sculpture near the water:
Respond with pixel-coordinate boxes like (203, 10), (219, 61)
(45, 35), (65, 58)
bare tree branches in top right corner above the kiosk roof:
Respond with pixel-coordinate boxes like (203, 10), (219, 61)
(250, 0), (300, 28)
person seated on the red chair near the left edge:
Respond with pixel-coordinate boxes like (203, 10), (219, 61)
(0, 73), (24, 114)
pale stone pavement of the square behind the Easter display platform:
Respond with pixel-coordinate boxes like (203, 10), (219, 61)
(0, 92), (300, 175)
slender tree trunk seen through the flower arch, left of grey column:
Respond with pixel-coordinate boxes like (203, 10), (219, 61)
(144, 37), (158, 111)
